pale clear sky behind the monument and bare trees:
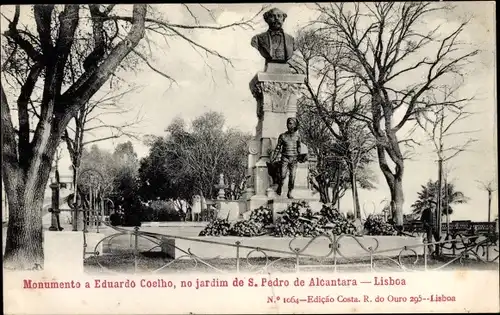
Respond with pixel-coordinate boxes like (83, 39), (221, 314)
(2, 1), (498, 220)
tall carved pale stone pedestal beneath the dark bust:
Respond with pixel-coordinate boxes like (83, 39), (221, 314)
(244, 64), (319, 220)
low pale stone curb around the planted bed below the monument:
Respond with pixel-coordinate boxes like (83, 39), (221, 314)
(162, 236), (423, 259)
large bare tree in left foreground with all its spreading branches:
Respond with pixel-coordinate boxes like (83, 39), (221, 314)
(0, 4), (260, 269)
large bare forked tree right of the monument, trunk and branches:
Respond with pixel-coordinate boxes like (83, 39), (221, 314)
(316, 2), (478, 226)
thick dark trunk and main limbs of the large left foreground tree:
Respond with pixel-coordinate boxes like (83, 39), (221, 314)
(0, 4), (147, 269)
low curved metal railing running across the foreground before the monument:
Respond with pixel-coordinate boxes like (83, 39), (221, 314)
(84, 218), (499, 273)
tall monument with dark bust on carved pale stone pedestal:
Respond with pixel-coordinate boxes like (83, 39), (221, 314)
(244, 8), (319, 220)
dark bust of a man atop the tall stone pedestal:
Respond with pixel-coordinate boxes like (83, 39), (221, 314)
(251, 8), (296, 64)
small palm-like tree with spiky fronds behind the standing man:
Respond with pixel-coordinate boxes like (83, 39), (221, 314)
(411, 180), (469, 217)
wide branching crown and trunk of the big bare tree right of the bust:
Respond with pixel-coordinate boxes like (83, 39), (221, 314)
(302, 2), (478, 226)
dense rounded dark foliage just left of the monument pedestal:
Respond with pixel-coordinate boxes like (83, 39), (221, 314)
(139, 112), (251, 200)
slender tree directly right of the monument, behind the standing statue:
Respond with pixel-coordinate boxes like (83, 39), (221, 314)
(292, 28), (375, 218)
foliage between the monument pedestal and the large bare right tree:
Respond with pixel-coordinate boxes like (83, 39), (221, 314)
(294, 55), (375, 215)
